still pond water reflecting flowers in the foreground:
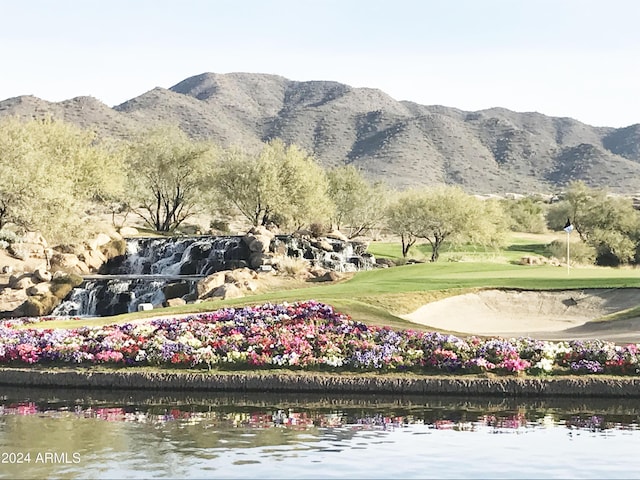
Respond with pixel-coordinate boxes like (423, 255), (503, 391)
(0, 387), (640, 479)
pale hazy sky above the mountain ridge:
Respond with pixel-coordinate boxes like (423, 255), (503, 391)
(0, 0), (640, 127)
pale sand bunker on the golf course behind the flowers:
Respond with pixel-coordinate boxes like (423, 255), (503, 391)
(402, 288), (640, 342)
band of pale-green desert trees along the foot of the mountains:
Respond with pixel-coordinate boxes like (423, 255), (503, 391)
(0, 114), (640, 266)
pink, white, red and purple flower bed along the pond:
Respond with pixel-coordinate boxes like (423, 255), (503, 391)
(0, 301), (640, 375)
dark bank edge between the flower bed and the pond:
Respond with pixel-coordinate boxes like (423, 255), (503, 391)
(0, 368), (640, 398)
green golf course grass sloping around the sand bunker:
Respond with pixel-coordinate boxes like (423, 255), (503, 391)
(37, 236), (640, 329)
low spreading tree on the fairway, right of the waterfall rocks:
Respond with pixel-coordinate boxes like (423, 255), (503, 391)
(388, 186), (504, 262)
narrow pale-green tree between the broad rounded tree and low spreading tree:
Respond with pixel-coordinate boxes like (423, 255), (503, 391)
(327, 165), (389, 238)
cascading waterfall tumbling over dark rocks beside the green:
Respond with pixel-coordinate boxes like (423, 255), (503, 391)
(52, 236), (373, 316)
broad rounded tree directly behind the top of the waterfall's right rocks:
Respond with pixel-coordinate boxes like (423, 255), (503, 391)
(213, 139), (332, 227)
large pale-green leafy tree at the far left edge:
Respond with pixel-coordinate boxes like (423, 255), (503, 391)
(0, 118), (123, 242)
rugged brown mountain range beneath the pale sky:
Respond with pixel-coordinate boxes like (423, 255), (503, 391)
(0, 73), (640, 193)
